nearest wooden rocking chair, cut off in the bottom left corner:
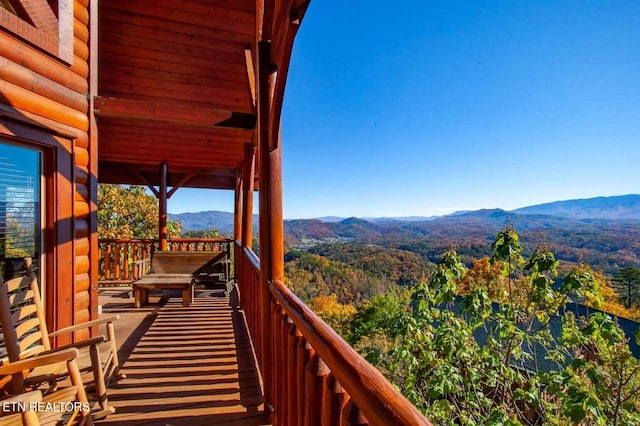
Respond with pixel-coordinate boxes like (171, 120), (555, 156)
(0, 348), (93, 426)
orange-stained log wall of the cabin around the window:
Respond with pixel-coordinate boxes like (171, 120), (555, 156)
(0, 0), (97, 344)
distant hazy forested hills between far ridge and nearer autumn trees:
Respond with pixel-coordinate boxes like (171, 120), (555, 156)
(285, 210), (640, 275)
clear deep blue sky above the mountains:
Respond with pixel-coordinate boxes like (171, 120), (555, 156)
(169, 0), (640, 218)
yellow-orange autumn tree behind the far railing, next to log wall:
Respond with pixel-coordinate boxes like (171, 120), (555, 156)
(98, 184), (180, 238)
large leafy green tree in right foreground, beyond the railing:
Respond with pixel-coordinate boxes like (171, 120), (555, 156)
(376, 228), (640, 425)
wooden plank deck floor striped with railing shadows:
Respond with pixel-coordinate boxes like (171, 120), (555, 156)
(97, 290), (265, 426)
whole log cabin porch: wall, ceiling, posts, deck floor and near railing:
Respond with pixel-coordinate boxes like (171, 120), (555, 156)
(0, 0), (429, 425)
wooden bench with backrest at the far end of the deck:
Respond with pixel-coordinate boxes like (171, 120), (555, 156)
(133, 251), (225, 308)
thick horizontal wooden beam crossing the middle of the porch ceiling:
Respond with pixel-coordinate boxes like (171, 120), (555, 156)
(95, 97), (255, 129)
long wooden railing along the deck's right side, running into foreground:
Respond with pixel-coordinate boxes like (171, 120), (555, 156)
(235, 243), (431, 425)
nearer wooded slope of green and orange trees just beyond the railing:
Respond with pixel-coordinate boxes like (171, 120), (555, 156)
(286, 228), (640, 425)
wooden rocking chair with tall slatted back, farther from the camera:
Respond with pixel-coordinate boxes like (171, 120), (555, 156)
(0, 258), (124, 418)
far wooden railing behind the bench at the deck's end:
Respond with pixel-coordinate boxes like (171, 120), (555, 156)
(98, 238), (232, 285)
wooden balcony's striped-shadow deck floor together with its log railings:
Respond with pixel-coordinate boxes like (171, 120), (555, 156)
(98, 239), (429, 425)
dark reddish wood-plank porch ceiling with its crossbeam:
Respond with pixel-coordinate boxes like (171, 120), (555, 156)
(95, 0), (308, 189)
